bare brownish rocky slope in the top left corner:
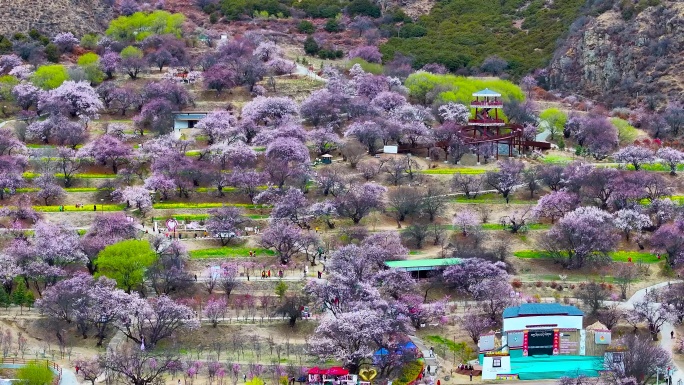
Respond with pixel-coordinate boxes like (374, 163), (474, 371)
(0, 0), (112, 36)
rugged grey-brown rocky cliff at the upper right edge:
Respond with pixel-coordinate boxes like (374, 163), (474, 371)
(549, 1), (684, 107)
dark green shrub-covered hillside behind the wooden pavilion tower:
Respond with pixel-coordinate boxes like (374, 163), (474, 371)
(381, 0), (584, 75)
